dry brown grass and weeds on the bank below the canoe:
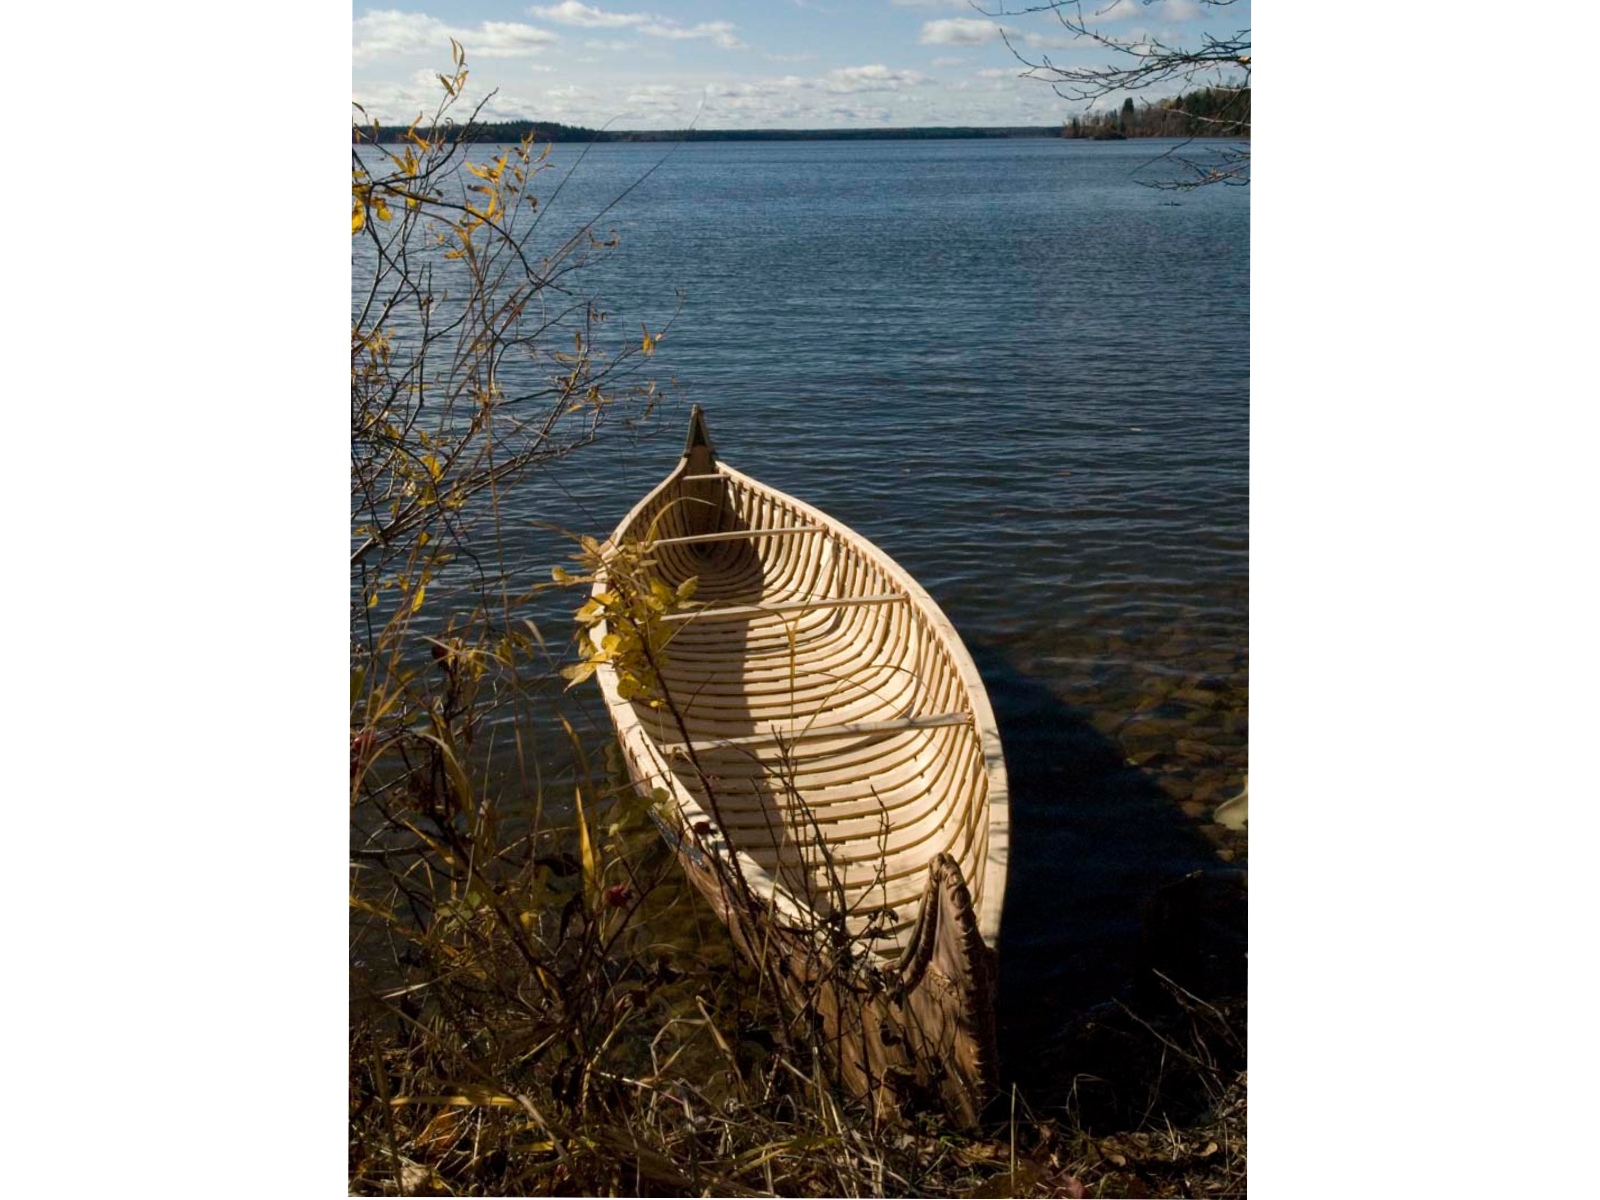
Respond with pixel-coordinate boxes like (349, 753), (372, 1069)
(349, 729), (1246, 1197)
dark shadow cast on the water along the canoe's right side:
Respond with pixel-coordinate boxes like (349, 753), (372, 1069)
(970, 642), (1243, 1104)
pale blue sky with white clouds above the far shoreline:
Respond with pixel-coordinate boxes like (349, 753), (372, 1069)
(352, 0), (1250, 130)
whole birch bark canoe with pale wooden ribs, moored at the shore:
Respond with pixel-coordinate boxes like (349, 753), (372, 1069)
(594, 406), (1010, 1125)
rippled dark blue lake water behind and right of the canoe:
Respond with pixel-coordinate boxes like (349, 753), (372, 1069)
(350, 139), (1250, 1068)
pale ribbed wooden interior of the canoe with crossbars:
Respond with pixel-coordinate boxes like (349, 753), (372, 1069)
(608, 437), (1005, 958)
